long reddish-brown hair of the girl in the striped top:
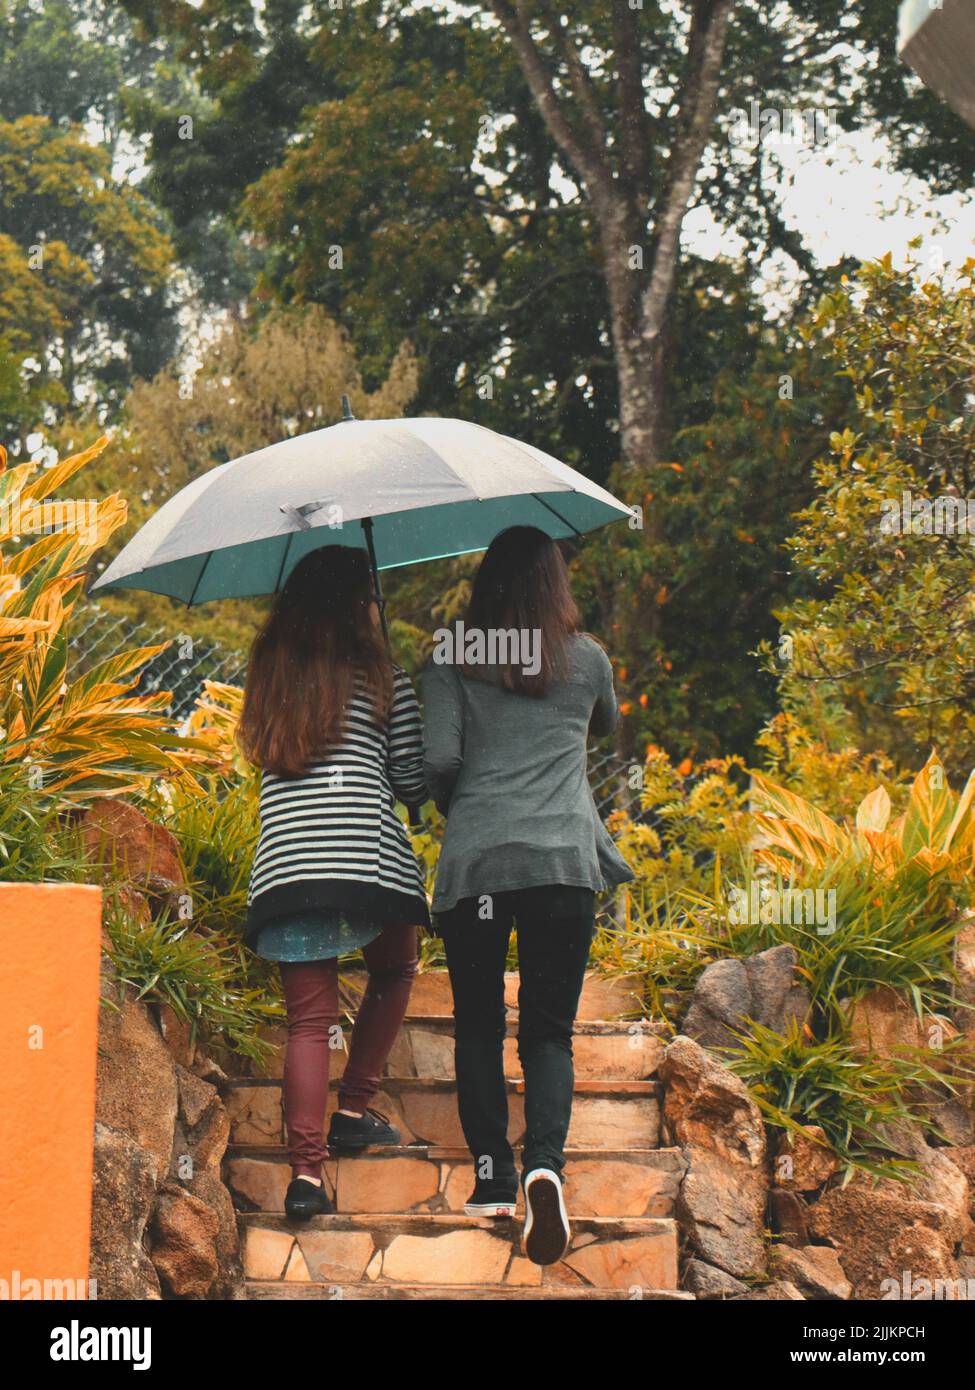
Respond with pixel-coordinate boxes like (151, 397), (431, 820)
(239, 545), (392, 777)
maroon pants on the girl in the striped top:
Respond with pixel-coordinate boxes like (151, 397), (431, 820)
(281, 927), (416, 1177)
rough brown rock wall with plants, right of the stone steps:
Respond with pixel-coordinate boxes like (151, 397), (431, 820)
(659, 939), (975, 1301)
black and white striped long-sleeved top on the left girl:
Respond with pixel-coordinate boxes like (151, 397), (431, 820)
(246, 667), (428, 937)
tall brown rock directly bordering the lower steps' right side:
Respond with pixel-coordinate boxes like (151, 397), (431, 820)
(659, 1037), (768, 1277)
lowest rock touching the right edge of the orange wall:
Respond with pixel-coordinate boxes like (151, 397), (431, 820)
(89, 1123), (160, 1300)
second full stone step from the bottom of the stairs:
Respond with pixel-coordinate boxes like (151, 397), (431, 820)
(225, 1145), (686, 1216)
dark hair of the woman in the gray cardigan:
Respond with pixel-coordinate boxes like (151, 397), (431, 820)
(462, 525), (580, 699)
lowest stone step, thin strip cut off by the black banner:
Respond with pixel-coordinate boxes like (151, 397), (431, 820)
(246, 1279), (695, 1302)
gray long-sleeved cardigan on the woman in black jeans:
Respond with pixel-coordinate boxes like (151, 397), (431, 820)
(423, 635), (633, 912)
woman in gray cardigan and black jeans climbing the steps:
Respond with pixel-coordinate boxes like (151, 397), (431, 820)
(423, 527), (633, 1264)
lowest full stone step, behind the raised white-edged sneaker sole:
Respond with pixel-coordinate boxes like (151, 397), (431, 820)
(239, 1213), (677, 1298)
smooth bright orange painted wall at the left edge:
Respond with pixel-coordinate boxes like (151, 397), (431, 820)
(0, 884), (102, 1293)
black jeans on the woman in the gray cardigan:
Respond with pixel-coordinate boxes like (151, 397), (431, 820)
(437, 887), (595, 1180)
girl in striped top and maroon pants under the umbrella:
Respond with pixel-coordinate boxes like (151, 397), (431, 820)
(241, 545), (430, 1220)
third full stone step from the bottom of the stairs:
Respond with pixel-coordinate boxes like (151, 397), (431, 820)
(224, 1077), (661, 1150)
